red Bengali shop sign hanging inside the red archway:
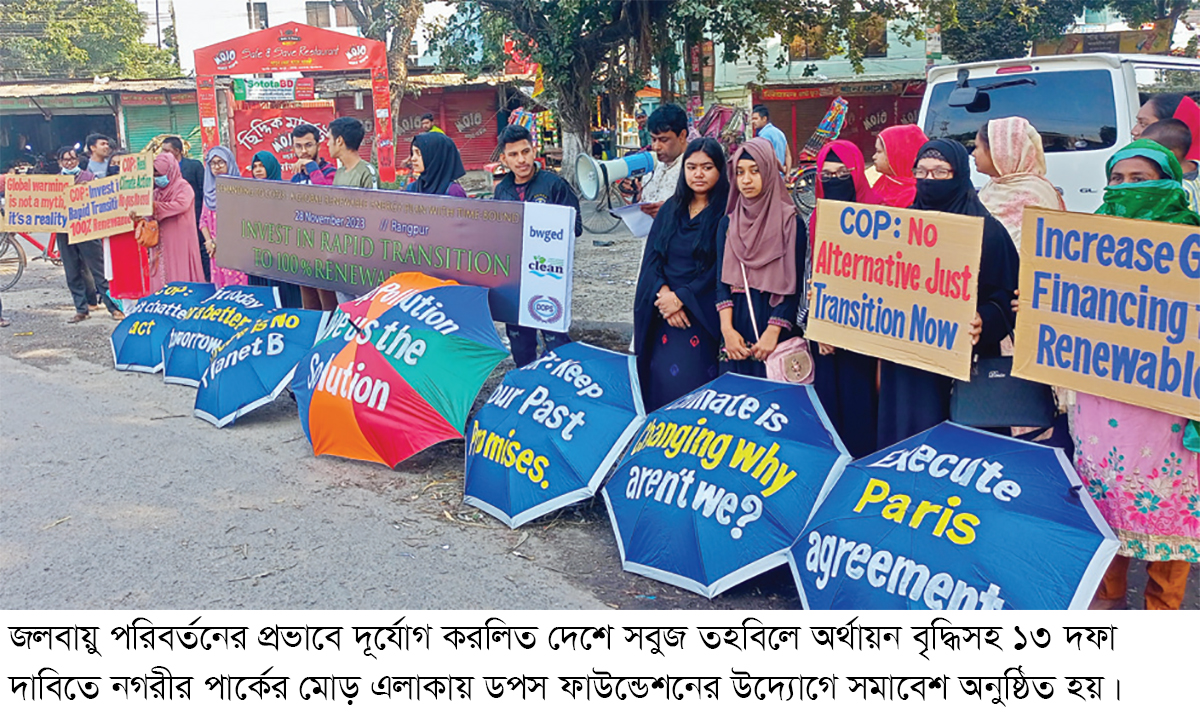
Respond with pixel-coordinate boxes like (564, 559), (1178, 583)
(233, 107), (334, 181)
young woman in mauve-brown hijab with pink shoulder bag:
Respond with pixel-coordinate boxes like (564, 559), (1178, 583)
(716, 138), (809, 377)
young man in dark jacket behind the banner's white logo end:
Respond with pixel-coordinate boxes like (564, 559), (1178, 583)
(493, 125), (583, 367)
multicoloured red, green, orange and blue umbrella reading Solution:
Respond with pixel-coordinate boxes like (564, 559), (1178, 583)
(292, 274), (508, 467)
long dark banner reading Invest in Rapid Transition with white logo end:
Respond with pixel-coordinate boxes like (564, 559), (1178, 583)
(217, 176), (575, 332)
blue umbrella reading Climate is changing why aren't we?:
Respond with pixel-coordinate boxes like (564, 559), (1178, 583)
(604, 374), (850, 597)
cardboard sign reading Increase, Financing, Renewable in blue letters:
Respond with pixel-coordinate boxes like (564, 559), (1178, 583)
(1013, 209), (1200, 420)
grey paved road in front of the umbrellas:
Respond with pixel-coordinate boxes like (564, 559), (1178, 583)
(0, 251), (1200, 609)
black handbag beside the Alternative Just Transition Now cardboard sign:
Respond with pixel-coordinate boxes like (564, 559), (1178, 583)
(950, 301), (1056, 428)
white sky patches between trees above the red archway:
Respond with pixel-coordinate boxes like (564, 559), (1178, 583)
(166, 0), (451, 74)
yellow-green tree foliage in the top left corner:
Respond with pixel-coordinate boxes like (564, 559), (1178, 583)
(0, 0), (180, 80)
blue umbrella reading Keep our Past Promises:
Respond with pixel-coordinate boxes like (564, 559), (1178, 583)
(463, 343), (646, 529)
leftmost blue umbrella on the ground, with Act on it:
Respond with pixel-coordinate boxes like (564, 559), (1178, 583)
(109, 282), (216, 372)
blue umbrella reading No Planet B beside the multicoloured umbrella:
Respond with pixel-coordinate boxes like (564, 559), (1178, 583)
(194, 308), (329, 427)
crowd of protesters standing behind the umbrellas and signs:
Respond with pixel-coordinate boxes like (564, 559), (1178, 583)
(7, 95), (1200, 608)
